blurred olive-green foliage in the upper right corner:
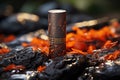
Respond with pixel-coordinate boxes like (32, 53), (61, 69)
(59, 0), (120, 14)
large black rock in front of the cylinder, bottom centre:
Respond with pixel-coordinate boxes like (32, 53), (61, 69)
(38, 55), (87, 80)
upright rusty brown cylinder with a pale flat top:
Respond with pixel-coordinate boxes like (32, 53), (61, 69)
(48, 10), (66, 58)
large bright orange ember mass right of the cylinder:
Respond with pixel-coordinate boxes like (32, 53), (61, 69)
(66, 27), (116, 53)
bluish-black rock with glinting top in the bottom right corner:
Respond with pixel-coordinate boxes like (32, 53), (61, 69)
(93, 61), (120, 80)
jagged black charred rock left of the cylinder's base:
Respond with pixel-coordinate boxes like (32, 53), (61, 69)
(0, 47), (47, 68)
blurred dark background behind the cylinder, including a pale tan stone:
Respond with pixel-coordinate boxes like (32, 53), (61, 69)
(0, 0), (120, 34)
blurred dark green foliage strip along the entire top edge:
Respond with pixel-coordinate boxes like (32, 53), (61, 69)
(0, 0), (120, 15)
